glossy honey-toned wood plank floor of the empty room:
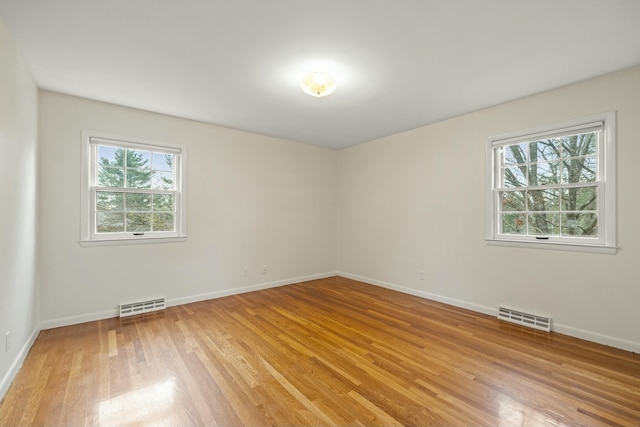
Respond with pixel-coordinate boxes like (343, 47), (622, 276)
(0, 277), (640, 426)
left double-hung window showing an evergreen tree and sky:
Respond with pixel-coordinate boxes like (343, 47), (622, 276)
(82, 132), (185, 241)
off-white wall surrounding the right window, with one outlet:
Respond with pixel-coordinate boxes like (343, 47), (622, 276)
(338, 68), (640, 352)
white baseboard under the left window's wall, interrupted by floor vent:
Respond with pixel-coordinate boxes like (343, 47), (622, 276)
(38, 271), (337, 331)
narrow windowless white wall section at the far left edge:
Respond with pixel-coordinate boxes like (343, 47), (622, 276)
(0, 18), (38, 398)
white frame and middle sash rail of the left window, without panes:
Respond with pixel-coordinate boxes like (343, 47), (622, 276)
(80, 129), (187, 246)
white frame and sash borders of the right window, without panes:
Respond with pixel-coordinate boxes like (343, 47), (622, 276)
(485, 111), (617, 254)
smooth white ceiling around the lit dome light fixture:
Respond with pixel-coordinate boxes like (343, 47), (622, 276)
(0, 0), (640, 149)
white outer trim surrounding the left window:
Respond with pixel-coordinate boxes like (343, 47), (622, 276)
(80, 129), (187, 246)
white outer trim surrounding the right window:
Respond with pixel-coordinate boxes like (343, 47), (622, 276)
(485, 111), (617, 254)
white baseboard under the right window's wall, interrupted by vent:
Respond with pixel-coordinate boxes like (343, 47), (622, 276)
(337, 271), (640, 353)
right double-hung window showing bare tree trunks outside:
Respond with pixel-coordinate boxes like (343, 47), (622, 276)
(487, 113), (616, 253)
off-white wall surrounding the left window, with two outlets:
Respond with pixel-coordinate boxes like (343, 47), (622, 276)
(40, 91), (337, 327)
